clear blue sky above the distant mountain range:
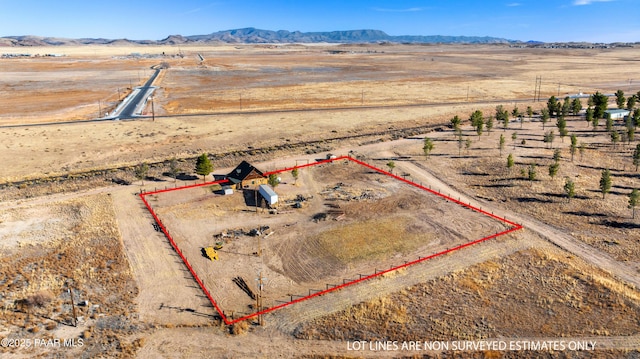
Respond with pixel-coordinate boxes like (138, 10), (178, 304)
(0, 0), (640, 42)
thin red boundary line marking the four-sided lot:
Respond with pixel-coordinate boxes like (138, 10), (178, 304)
(140, 156), (523, 325)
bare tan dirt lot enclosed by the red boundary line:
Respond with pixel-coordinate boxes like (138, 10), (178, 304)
(151, 161), (507, 316)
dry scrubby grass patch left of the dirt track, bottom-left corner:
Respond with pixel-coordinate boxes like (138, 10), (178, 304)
(0, 194), (145, 357)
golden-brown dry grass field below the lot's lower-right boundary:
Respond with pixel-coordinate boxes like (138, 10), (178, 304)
(296, 249), (640, 341)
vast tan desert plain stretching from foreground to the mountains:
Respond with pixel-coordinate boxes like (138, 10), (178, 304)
(0, 43), (640, 358)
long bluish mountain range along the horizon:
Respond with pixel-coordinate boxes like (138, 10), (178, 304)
(0, 27), (520, 46)
